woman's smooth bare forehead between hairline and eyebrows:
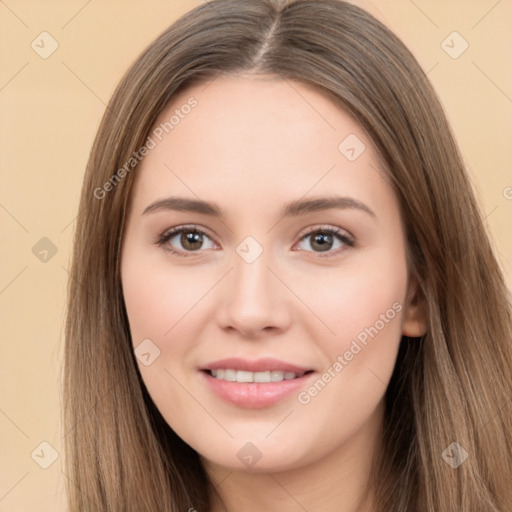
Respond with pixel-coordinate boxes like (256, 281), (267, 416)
(131, 75), (390, 216)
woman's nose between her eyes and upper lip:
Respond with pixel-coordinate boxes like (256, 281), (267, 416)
(217, 251), (292, 339)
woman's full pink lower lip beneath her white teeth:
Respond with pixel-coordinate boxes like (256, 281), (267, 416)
(201, 371), (314, 409)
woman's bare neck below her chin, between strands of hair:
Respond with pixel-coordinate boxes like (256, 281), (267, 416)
(203, 404), (383, 512)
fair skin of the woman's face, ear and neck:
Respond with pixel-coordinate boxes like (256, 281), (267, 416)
(121, 75), (425, 512)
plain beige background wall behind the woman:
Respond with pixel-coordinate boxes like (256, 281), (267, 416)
(0, 0), (512, 512)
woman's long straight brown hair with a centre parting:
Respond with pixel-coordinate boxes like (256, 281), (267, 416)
(64, 0), (512, 512)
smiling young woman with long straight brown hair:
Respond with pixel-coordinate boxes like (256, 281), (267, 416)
(65, 0), (512, 512)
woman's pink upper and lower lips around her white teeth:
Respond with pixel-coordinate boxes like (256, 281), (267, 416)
(200, 358), (316, 409)
